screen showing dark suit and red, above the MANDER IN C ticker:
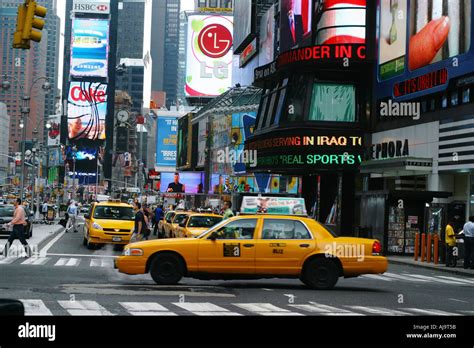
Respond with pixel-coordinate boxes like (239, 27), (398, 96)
(280, 0), (313, 52)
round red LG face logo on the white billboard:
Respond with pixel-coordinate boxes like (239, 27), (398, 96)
(198, 24), (232, 58)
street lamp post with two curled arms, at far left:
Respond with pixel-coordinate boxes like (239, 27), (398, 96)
(2, 75), (51, 200)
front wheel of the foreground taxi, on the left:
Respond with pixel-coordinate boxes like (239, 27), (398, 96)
(150, 254), (184, 285)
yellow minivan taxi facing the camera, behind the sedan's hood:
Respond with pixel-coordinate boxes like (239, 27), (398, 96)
(83, 201), (135, 250)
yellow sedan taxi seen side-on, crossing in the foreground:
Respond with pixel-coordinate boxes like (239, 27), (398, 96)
(115, 214), (387, 289)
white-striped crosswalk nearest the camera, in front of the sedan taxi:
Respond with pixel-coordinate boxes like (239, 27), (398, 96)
(15, 299), (469, 316)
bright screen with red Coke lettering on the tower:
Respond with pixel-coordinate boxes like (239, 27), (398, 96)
(68, 82), (107, 140)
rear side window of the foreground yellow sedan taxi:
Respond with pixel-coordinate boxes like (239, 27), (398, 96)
(262, 219), (311, 239)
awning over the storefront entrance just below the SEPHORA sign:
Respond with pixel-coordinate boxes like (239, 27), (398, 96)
(360, 157), (433, 177)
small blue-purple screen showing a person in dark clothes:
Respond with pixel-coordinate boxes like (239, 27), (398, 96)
(160, 172), (204, 194)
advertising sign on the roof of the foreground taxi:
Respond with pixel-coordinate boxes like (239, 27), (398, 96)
(240, 196), (308, 216)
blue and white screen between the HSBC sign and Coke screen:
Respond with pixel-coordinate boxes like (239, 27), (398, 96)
(71, 19), (109, 77)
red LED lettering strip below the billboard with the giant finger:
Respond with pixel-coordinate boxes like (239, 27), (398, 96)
(393, 68), (449, 98)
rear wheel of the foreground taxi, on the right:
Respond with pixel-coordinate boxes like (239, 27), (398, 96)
(301, 259), (338, 290)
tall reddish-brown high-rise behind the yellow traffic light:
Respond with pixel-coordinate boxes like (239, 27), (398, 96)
(0, 0), (60, 152)
